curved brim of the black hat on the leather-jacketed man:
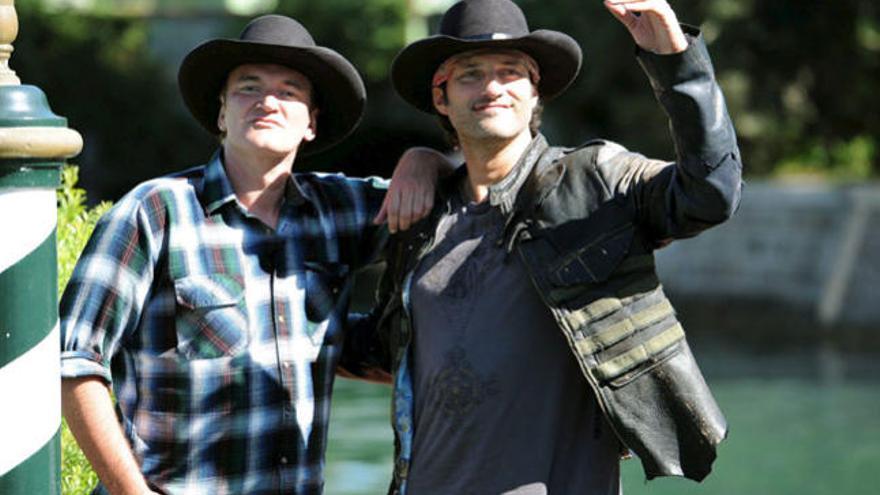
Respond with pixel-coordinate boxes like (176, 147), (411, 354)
(391, 29), (583, 113)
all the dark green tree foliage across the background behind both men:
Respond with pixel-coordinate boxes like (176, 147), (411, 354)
(12, 0), (880, 205)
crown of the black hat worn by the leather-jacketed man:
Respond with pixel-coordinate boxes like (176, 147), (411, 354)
(440, 0), (529, 40)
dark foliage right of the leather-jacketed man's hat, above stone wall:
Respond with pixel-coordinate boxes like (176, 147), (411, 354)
(519, 0), (880, 178)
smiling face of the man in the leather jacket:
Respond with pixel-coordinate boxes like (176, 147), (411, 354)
(433, 51), (538, 142)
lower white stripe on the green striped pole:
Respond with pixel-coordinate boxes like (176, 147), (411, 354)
(0, 323), (61, 476)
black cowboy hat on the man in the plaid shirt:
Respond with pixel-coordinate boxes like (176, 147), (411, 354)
(177, 15), (367, 155)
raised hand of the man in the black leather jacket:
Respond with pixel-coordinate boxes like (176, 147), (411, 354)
(605, 0), (688, 54)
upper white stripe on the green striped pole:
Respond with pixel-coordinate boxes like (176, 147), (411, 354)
(0, 188), (58, 273)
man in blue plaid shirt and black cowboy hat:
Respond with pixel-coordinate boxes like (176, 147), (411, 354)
(61, 16), (442, 495)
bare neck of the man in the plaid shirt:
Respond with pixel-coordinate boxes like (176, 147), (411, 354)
(223, 146), (296, 229)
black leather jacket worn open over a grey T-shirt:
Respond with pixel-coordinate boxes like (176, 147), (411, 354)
(344, 30), (742, 493)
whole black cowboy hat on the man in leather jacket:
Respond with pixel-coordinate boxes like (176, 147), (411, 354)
(391, 0), (582, 113)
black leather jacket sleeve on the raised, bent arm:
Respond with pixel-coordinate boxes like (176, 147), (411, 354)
(597, 26), (742, 242)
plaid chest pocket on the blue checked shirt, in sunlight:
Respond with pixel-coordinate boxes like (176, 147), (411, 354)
(174, 274), (250, 359)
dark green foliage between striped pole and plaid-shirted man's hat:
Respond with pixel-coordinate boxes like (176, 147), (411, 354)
(11, 4), (213, 199)
